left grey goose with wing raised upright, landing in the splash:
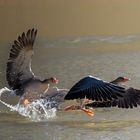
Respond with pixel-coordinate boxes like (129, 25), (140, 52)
(6, 29), (58, 104)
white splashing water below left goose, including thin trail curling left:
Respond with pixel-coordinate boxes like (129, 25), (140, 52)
(0, 88), (57, 121)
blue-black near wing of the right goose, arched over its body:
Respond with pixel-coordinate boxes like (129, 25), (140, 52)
(65, 76), (125, 101)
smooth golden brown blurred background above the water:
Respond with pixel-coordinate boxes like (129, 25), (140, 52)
(0, 0), (140, 41)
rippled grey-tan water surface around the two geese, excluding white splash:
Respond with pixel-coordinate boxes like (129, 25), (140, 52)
(0, 35), (140, 140)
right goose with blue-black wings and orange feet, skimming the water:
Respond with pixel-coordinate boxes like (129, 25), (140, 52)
(64, 75), (140, 116)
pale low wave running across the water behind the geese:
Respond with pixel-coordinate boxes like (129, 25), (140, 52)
(43, 34), (140, 48)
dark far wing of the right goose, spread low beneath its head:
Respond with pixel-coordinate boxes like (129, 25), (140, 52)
(86, 88), (140, 108)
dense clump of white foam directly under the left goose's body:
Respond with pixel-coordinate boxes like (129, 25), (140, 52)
(13, 99), (57, 121)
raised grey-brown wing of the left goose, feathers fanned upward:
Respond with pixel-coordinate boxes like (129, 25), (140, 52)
(6, 29), (37, 89)
